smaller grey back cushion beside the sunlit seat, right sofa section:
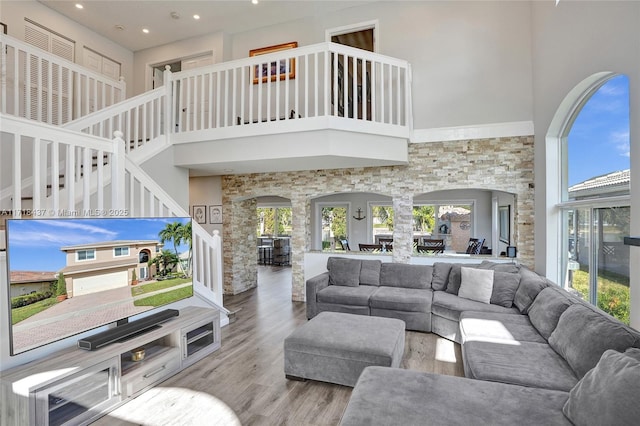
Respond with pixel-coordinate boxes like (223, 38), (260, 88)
(528, 286), (573, 340)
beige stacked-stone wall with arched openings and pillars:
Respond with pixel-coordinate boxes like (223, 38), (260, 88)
(222, 136), (534, 301)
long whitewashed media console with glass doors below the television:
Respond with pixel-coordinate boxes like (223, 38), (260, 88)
(0, 307), (220, 426)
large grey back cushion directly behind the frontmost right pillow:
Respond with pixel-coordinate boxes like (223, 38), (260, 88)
(549, 303), (635, 377)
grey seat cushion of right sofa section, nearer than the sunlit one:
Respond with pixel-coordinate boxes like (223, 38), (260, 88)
(462, 341), (578, 392)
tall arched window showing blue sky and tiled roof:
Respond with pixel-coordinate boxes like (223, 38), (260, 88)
(548, 74), (630, 324)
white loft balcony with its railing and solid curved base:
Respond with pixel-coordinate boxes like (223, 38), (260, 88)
(171, 43), (411, 174)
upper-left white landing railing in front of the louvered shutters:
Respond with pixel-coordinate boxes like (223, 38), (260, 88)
(0, 35), (126, 125)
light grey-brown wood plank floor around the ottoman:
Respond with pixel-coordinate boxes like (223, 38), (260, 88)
(94, 266), (463, 426)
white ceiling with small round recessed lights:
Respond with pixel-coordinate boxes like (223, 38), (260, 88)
(38, 0), (371, 52)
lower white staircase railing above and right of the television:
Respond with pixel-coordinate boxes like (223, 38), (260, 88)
(0, 114), (228, 313)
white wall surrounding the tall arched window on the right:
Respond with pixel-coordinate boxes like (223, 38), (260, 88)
(531, 1), (640, 328)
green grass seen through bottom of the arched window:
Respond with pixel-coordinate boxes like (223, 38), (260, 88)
(572, 270), (631, 324)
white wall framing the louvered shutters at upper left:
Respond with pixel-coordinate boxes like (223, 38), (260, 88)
(0, 0), (133, 97)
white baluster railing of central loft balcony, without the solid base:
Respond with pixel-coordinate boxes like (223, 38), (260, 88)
(170, 43), (412, 138)
